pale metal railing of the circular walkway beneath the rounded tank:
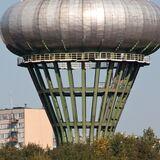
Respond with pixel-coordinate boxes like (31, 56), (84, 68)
(18, 52), (150, 65)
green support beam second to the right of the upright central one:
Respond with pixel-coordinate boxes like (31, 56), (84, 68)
(97, 62), (114, 138)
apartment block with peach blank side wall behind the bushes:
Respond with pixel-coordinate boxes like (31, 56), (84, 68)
(0, 107), (53, 148)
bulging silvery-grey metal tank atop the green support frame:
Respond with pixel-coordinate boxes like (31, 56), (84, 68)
(1, 0), (160, 56)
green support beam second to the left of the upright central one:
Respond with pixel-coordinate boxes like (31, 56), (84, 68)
(53, 62), (73, 142)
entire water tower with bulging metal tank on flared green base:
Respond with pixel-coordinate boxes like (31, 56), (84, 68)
(1, 0), (160, 145)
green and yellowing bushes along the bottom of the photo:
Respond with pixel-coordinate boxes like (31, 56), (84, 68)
(0, 128), (160, 160)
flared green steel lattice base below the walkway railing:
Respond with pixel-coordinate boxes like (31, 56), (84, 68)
(18, 53), (149, 145)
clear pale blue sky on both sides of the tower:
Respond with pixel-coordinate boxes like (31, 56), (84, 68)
(0, 0), (160, 137)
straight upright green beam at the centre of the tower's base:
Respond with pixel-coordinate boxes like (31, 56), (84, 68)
(81, 62), (86, 142)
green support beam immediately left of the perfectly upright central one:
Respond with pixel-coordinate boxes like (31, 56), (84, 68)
(67, 62), (79, 143)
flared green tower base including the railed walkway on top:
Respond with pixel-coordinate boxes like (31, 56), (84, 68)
(21, 53), (149, 146)
